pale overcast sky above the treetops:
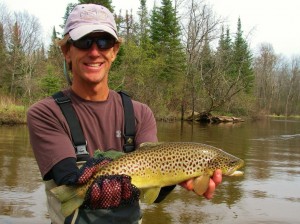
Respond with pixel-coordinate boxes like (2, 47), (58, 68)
(0, 0), (300, 57)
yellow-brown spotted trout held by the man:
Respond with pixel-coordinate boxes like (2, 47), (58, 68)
(50, 142), (244, 217)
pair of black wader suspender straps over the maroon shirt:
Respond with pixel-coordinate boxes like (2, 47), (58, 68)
(52, 91), (135, 158)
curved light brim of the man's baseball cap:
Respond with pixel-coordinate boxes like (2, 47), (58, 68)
(69, 25), (118, 40)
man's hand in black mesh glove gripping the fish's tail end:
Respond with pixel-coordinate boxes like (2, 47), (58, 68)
(69, 156), (140, 209)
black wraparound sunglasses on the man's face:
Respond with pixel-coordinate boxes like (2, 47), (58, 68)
(68, 37), (116, 50)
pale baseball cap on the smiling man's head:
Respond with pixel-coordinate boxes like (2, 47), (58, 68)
(63, 4), (118, 40)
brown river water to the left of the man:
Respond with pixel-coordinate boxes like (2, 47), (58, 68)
(0, 126), (47, 223)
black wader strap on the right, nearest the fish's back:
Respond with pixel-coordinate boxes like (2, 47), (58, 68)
(118, 91), (135, 153)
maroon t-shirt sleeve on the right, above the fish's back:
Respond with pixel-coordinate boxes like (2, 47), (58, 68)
(133, 101), (157, 147)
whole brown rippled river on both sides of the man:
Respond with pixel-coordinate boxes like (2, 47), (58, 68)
(0, 119), (300, 224)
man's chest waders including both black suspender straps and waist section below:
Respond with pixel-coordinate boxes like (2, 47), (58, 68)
(45, 91), (141, 224)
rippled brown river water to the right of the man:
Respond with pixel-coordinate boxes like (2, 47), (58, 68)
(155, 120), (300, 223)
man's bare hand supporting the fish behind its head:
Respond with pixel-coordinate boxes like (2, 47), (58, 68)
(180, 169), (222, 199)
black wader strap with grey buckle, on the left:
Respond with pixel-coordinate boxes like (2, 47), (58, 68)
(52, 91), (89, 161)
